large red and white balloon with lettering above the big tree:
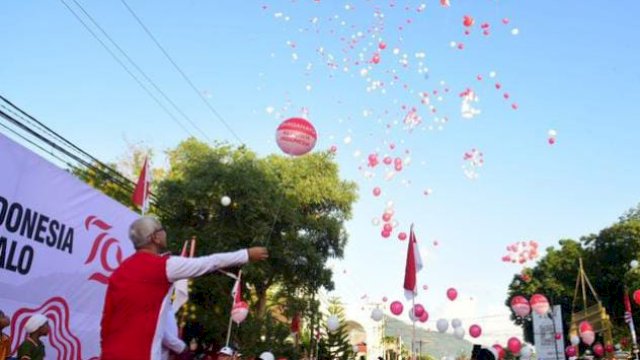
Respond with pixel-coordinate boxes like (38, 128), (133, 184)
(276, 118), (318, 156)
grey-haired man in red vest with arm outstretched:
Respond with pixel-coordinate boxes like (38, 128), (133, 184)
(100, 216), (269, 360)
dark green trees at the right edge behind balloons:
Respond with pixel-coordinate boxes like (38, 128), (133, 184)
(505, 217), (640, 341)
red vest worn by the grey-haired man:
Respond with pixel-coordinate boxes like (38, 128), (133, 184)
(100, 252), (171, 360)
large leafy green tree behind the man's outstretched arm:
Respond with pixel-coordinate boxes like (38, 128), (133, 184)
(152, 139), (356, 354)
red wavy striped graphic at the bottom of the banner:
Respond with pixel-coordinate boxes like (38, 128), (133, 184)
(11, 296), (82, 360)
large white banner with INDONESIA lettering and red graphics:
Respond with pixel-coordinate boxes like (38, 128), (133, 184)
(0, 134), (138, 360)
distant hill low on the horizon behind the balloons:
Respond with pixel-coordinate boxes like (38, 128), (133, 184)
(384, 316), (473, 359)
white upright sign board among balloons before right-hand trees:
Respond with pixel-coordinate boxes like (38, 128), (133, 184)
(531, 305), (564, 360)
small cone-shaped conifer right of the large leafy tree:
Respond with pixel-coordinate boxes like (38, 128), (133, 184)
(319, 297), (355, 360)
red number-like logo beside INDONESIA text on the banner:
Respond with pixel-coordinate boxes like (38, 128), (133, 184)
(84, 215), (122, 285)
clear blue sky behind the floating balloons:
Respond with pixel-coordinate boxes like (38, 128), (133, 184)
(0, 0), (640, 342)
